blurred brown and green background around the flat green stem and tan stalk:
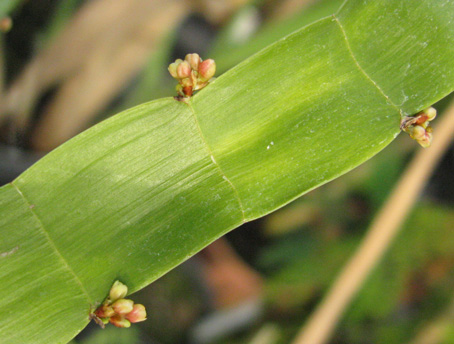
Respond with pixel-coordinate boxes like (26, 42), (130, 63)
(0, 0), (454, 344)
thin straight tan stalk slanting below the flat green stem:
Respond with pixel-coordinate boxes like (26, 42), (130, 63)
(293, 104), (454, 344)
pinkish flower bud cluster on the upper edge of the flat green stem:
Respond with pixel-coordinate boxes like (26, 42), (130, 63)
(168, 53), (216, 98)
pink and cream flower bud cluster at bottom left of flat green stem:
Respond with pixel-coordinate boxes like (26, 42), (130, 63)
(94, 281), (147, 327)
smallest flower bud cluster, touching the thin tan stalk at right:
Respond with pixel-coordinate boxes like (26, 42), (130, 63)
(400, 107), (437, 148)
